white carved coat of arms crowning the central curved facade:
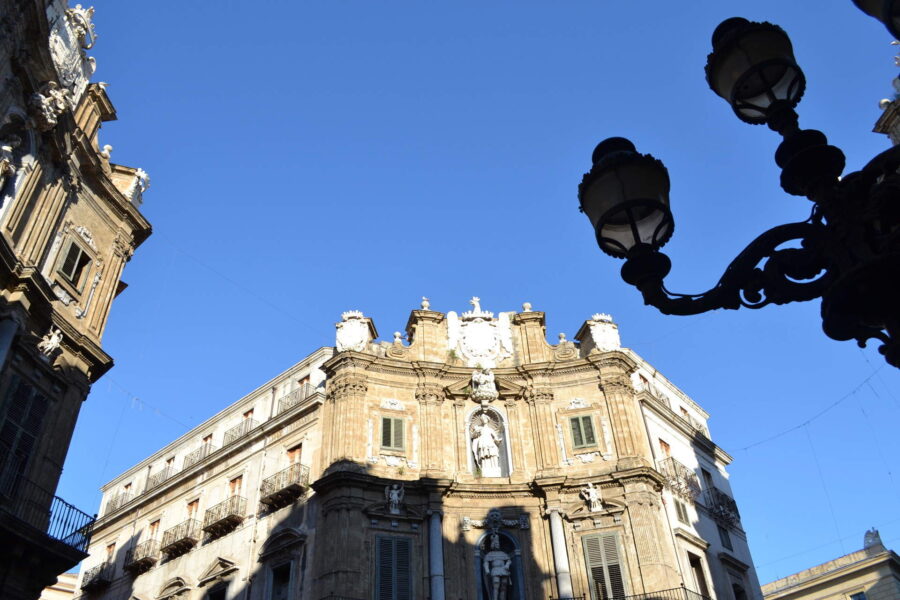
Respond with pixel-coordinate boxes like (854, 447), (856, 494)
(447, 297), (513, 368)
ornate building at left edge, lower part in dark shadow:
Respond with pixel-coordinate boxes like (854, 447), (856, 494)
(0, 0), (150, 600)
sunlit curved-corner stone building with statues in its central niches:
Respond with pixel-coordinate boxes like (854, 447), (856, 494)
(79, 298), (761, 600)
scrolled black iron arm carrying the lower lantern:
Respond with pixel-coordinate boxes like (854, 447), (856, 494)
(635, 220), (831, 315)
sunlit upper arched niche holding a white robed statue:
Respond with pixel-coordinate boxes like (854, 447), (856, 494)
(465, 406), (513, 477)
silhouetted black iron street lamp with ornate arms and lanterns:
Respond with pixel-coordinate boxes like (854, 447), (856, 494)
(578, 15), (900, 368)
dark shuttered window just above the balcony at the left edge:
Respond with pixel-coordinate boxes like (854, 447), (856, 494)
(0, 373), (49, 494)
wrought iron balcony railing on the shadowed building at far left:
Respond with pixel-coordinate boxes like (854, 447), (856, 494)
(0, 473), (95, 553)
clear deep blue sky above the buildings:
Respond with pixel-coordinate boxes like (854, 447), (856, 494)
(59, 0), (900, 582)
